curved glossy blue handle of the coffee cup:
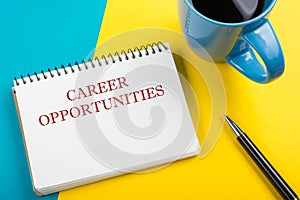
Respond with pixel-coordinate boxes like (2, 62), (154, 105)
(225, 19), (284, 83)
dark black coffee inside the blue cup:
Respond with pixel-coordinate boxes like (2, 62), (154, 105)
(192, 0), (265, 23)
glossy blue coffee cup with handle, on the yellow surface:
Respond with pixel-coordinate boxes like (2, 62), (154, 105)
(178, 0), (284, 83)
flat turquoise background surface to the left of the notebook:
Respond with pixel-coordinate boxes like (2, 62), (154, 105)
(0, 0), (106, 200)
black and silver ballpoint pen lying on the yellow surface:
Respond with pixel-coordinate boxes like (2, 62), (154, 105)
(225, 115), (299, 200)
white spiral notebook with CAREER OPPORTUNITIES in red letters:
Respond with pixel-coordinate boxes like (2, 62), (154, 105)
(13, 42), (200, 195)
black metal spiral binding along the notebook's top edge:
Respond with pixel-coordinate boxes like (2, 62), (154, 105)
(14, 42), (168, 86)
